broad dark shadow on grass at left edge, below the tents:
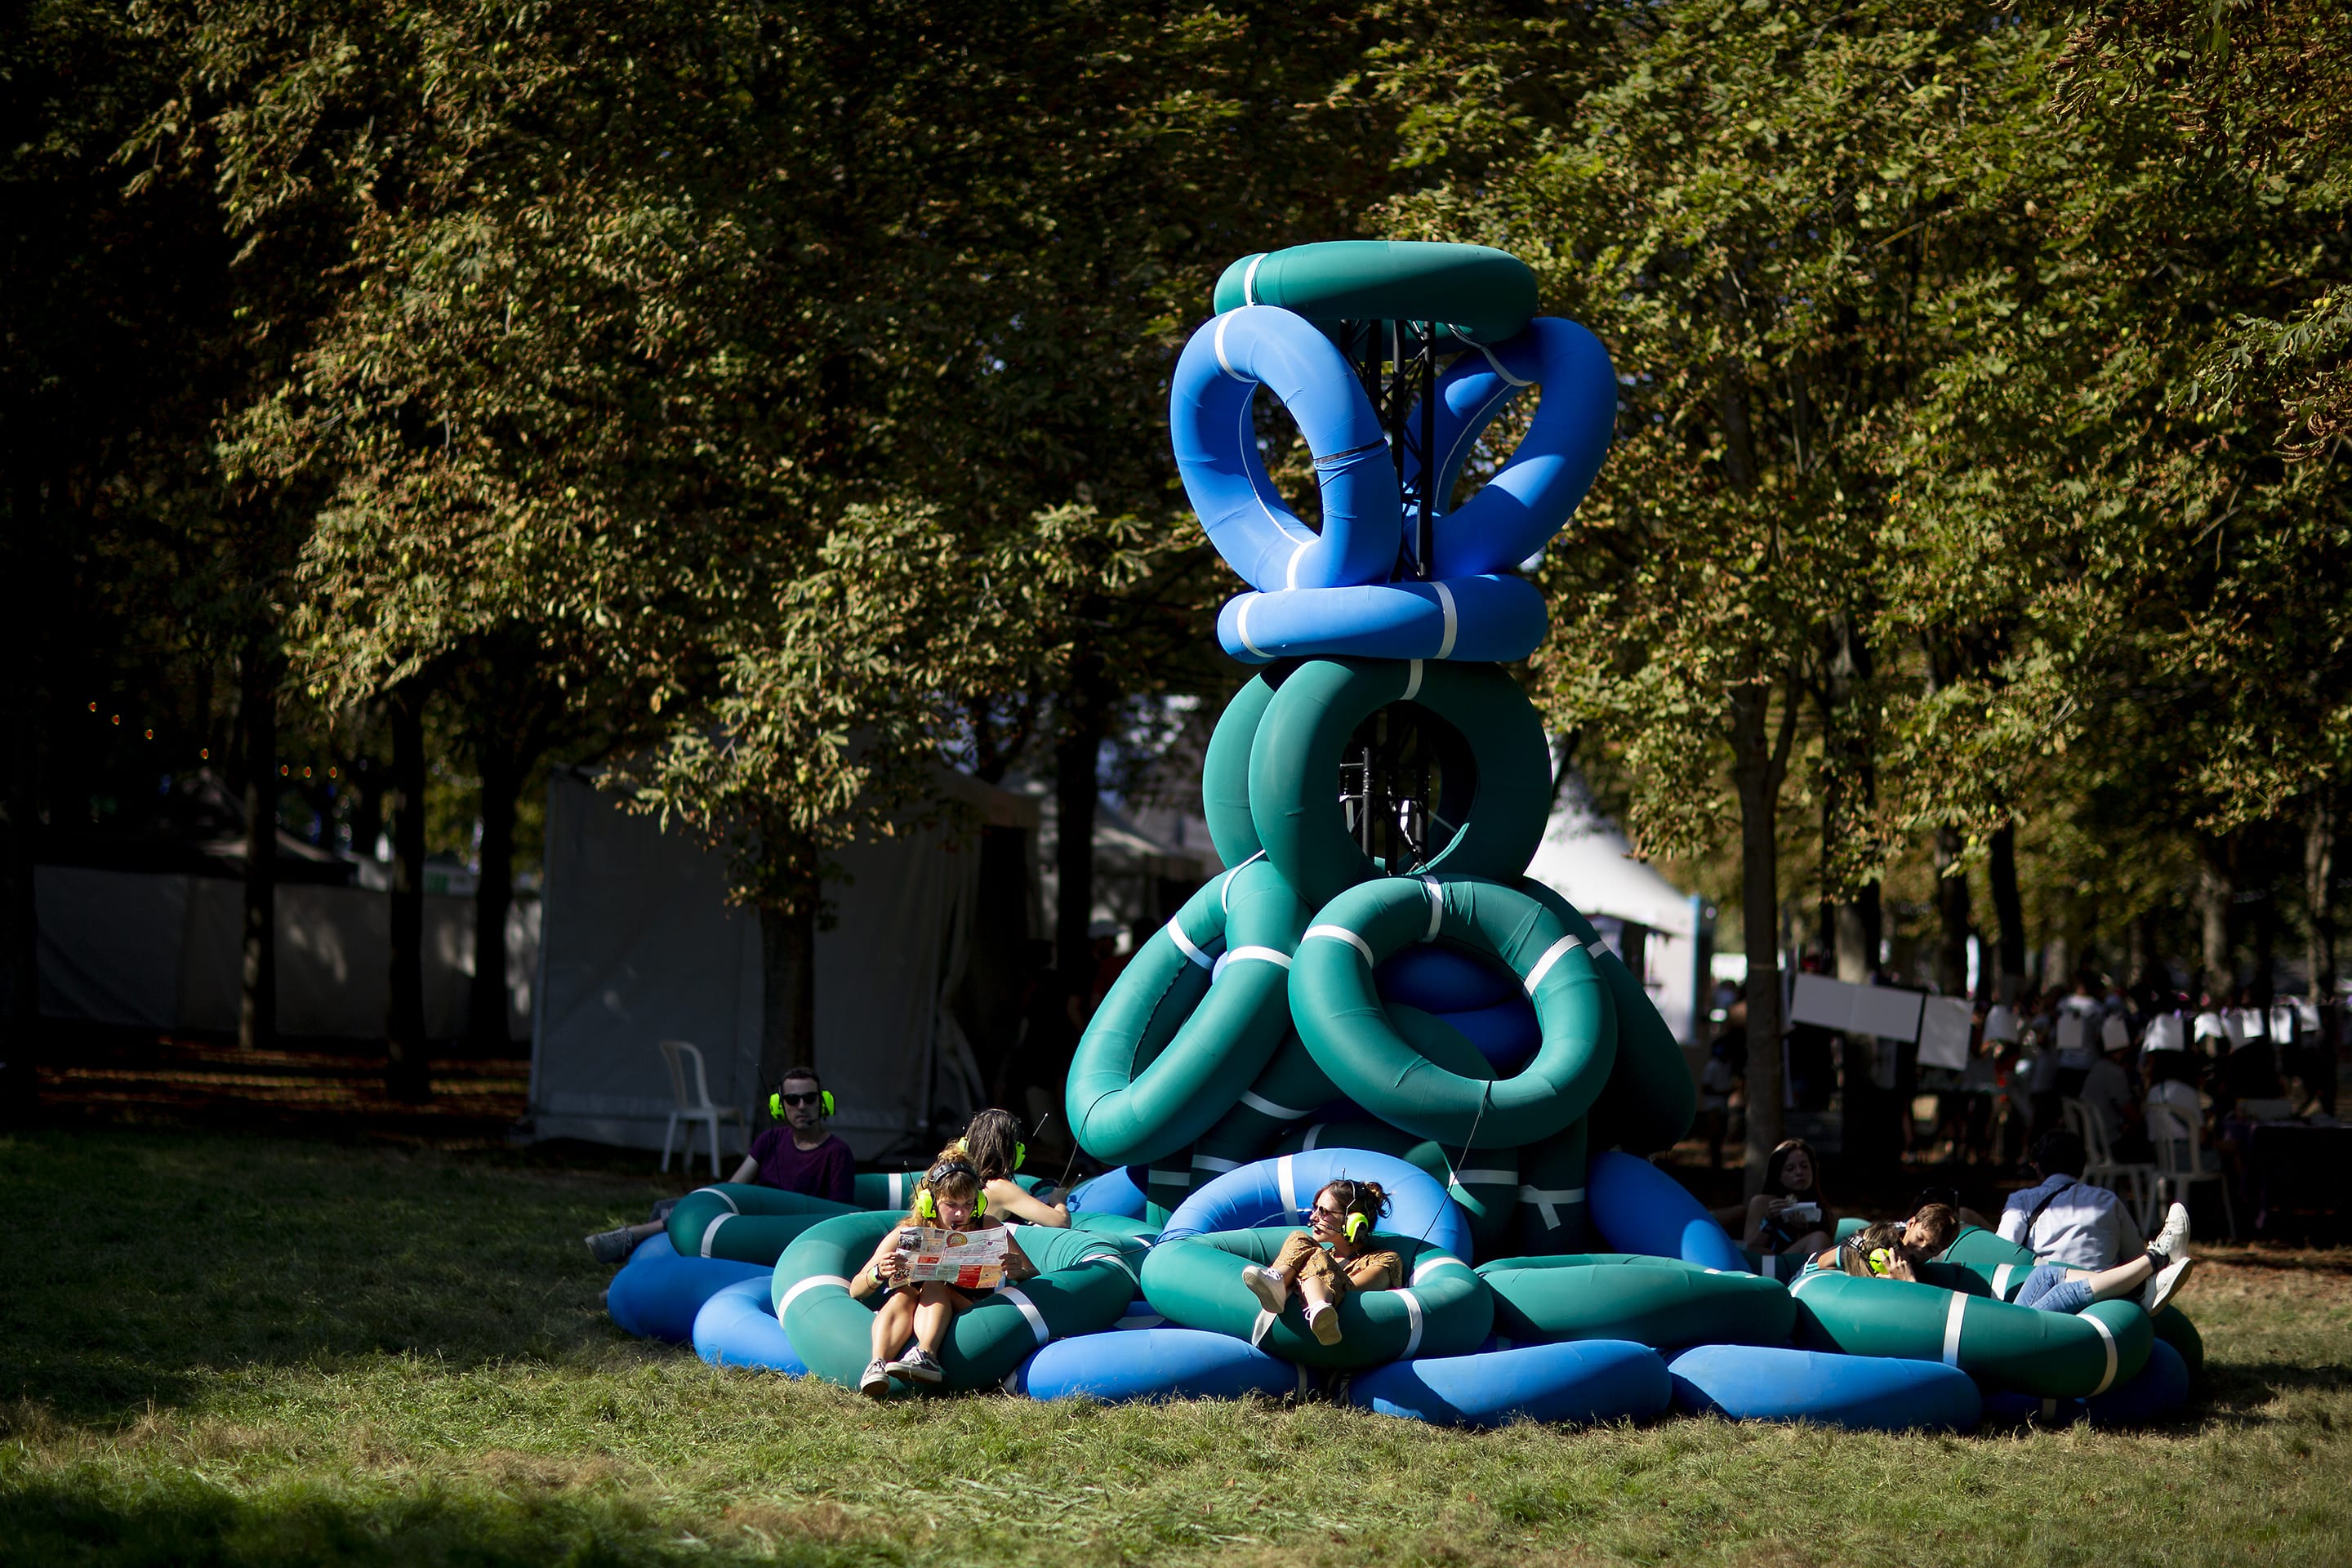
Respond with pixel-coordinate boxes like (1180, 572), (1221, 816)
(0, 1131), (644, 1424)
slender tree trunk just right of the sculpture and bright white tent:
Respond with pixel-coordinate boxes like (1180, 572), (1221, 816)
(1731, 682), (1797, 1196)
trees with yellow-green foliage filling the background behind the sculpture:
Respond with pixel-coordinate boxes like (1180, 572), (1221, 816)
(0, 0), (2352, 1170)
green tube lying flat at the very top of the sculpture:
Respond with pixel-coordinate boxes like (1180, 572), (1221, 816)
(1211, 240), (1536, 348)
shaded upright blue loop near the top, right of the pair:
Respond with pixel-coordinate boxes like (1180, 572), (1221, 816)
(1409, 315), (1618, 578)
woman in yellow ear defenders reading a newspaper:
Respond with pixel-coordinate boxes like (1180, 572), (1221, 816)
(849, 1147), (1037, 1399)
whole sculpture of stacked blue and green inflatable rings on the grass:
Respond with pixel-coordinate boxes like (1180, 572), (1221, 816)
(609, 242), (2199, 1429)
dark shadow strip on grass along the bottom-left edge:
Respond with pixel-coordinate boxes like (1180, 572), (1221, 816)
(0, 1477), (875, 1568)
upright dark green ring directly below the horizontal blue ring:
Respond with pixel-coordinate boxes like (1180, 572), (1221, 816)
(1249, 658), (1552, 907)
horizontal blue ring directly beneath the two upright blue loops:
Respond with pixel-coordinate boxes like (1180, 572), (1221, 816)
(1216, 576), (1550, 666)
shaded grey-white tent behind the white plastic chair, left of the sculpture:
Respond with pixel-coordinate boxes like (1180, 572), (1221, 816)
(532, 768), (1037, 1159)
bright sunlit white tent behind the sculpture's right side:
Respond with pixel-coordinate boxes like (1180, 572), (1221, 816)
(1526, 768), (1713, 1046)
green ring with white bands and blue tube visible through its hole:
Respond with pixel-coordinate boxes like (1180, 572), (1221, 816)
(1291, 877), (1616, 1150)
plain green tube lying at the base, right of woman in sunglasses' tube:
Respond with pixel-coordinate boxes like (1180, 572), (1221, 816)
(1477, 1253), (1797, 1349)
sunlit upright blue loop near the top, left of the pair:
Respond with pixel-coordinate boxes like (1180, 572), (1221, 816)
(1169, 305), (1383, 590)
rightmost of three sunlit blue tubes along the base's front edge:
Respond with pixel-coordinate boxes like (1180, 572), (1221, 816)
(1670, 1345), (1985, 1432)
